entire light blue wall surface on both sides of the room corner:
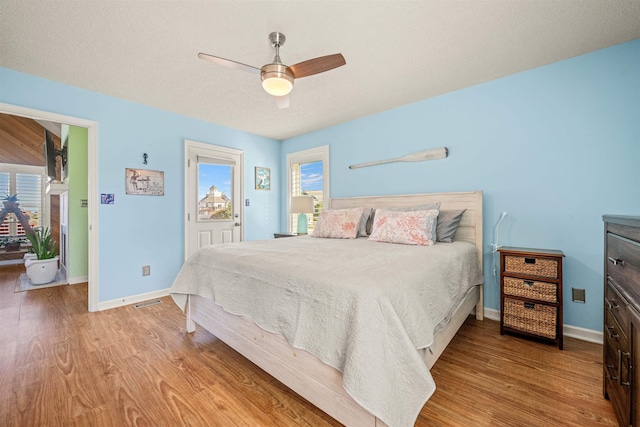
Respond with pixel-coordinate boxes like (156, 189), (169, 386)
(0, 40), (640, 330)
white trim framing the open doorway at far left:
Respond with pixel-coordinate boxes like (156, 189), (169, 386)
(0, 102), (99, 311)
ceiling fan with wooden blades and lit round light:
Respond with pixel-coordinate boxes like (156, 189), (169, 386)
(198, 32), (347, 108)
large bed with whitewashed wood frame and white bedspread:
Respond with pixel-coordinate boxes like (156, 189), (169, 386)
(171, 191), (483, 426)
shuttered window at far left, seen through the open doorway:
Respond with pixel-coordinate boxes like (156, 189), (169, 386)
(0, 163), (49, 236)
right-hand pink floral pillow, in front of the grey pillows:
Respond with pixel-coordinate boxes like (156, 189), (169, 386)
(369, 209), (438, 246)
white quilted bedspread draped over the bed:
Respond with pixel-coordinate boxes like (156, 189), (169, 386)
(171, 236), (483, 427)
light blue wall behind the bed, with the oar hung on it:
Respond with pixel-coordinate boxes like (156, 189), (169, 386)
(280, 40), (640, 330)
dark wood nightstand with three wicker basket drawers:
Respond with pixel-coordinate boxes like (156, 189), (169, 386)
(498, 247), (564, 350)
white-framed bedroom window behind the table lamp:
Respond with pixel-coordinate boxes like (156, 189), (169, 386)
(287, 145), (330, 234)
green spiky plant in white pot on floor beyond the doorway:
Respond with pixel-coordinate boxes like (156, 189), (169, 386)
(24, 227), (58, 285)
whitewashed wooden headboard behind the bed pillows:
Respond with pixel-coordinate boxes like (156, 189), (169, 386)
(329, 191), (483, 269)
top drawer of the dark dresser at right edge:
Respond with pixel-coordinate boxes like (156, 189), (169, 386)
(606, 233), (640, 288)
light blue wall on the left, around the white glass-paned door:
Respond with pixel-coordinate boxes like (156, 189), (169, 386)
(0, 68), (282, 302)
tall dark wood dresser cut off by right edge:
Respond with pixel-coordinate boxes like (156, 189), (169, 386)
(602, 215), (640, 426)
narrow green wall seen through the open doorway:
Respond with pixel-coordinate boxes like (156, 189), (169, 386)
(67, 126), (89, 282)
